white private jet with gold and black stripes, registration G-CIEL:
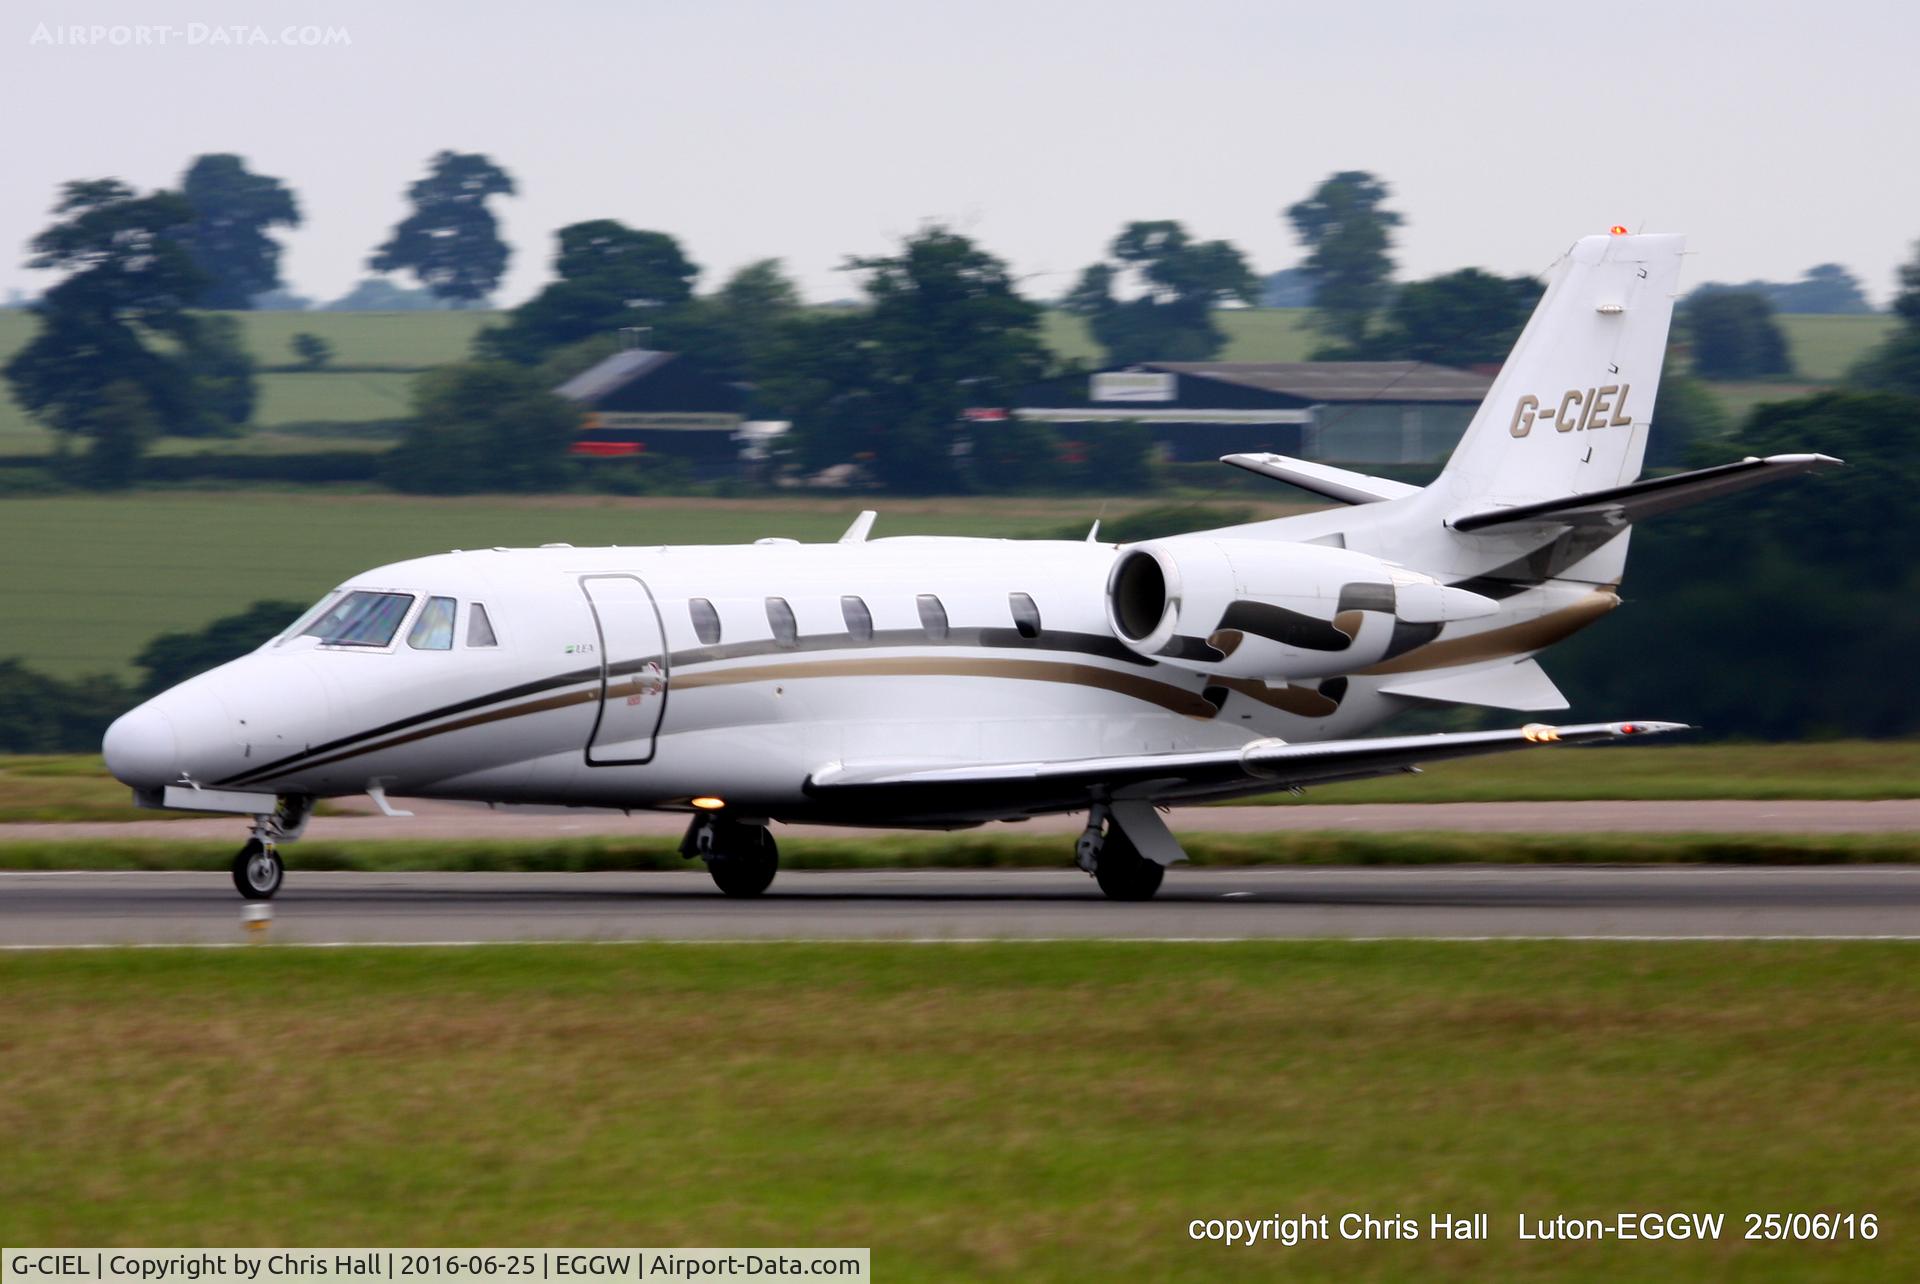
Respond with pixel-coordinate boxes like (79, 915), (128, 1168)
(104, 228), (1839, 900)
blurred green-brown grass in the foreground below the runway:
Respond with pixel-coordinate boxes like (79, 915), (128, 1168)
(0, 942), (1920, 1280)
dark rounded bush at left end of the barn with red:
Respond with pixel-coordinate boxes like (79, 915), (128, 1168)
(386, 361), (580, 495)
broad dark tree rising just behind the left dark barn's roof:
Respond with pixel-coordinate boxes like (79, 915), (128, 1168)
(476, 219), (701, 365)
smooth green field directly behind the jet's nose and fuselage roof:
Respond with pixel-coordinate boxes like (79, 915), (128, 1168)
(0, 491), (1296, 676)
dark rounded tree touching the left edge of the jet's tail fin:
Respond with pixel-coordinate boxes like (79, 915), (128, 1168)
(1363, 267), (1544, 367)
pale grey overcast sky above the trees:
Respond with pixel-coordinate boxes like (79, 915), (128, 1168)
(0, 0), (1920, 301)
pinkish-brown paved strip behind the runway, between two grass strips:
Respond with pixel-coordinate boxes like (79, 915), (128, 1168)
(15, 798), (1920, 844)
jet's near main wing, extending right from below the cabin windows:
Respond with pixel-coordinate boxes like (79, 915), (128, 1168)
(806, 722), (1688, 816)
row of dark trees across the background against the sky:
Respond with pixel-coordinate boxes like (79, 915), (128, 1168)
(6, 152), (1891, 491)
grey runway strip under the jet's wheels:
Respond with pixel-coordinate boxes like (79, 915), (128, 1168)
(0, 866), (1920, 948)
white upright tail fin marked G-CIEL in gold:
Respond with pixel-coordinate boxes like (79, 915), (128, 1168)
(1430, 234), (1686, 509)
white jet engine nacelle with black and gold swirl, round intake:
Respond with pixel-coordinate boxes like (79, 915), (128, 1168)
(1106, 535), (1500, 681)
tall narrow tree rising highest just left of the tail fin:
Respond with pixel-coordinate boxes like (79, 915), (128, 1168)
(1286, 169), (1400, 353)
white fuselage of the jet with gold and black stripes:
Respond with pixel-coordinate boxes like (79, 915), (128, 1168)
(109, 537), (1551, 823)
